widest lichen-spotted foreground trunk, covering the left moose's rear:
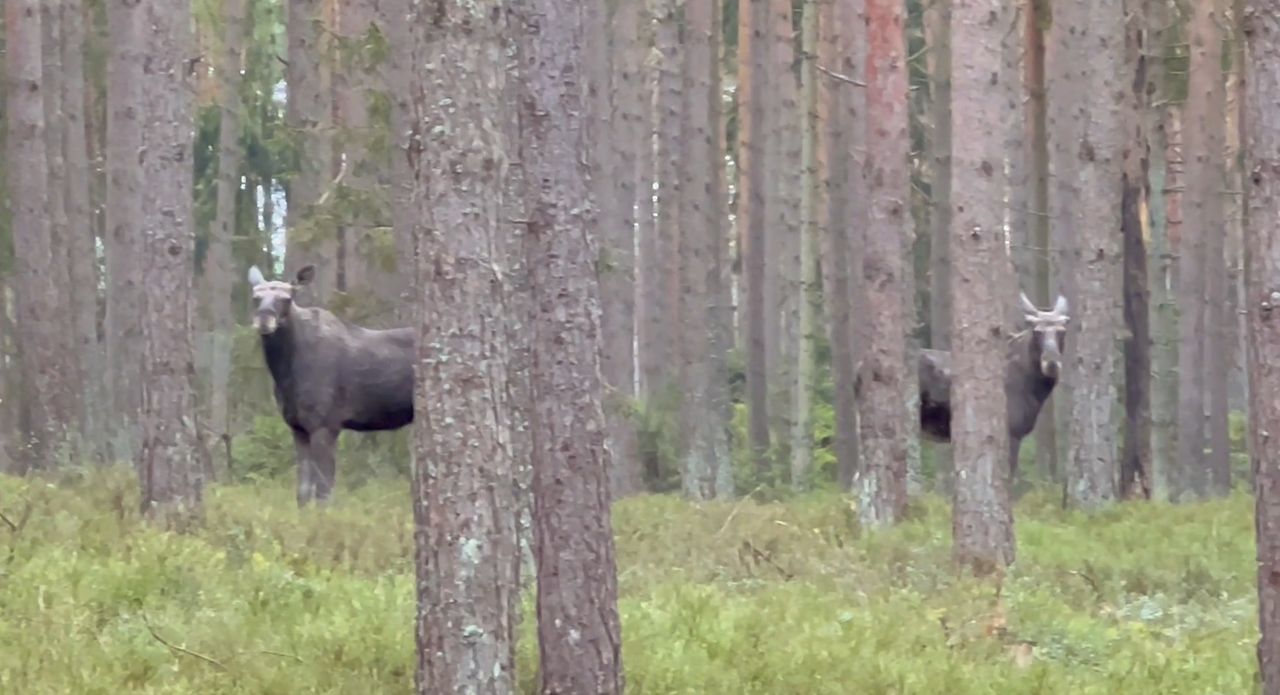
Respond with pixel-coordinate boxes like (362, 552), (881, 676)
(411, 0), (520, 695)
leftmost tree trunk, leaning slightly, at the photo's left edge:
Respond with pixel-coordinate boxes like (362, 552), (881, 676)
(5, 0), (69, 470)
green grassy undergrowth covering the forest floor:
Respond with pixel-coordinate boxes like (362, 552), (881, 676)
(0, 471), (1256, 695)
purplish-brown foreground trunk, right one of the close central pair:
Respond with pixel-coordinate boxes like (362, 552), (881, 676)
(521, 0), (622, 695)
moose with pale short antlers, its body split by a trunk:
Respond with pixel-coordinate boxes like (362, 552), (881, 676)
(919, 292), (1069, 481)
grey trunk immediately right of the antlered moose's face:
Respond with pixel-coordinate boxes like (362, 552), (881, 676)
(1048, 0), (1132, 508)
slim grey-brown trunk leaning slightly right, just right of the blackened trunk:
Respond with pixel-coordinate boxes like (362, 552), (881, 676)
(1172, 0), (1225, 498)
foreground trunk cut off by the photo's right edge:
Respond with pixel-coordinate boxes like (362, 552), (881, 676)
(1244, 5), (1280, 695)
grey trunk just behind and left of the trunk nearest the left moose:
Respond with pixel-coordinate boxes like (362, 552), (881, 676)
(104, 0), (145, 473)
